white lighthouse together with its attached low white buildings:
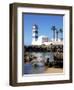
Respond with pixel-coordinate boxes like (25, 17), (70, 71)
(32, 24), (63, 45)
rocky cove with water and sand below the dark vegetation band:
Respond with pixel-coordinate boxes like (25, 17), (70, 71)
(24, 48), (63, 74)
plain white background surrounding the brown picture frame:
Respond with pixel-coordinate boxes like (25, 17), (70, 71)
(0, 0), (74, 90)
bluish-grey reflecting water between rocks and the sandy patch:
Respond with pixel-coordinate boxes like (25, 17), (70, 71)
(24, 52), (54, 74)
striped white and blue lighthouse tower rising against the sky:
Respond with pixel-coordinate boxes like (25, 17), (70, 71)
(32, 24), (38, 43)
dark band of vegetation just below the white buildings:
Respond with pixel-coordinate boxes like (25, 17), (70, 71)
(24, 45), (63, 52)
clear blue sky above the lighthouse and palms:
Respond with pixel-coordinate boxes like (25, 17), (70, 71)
(23, 14), (63, 45)
